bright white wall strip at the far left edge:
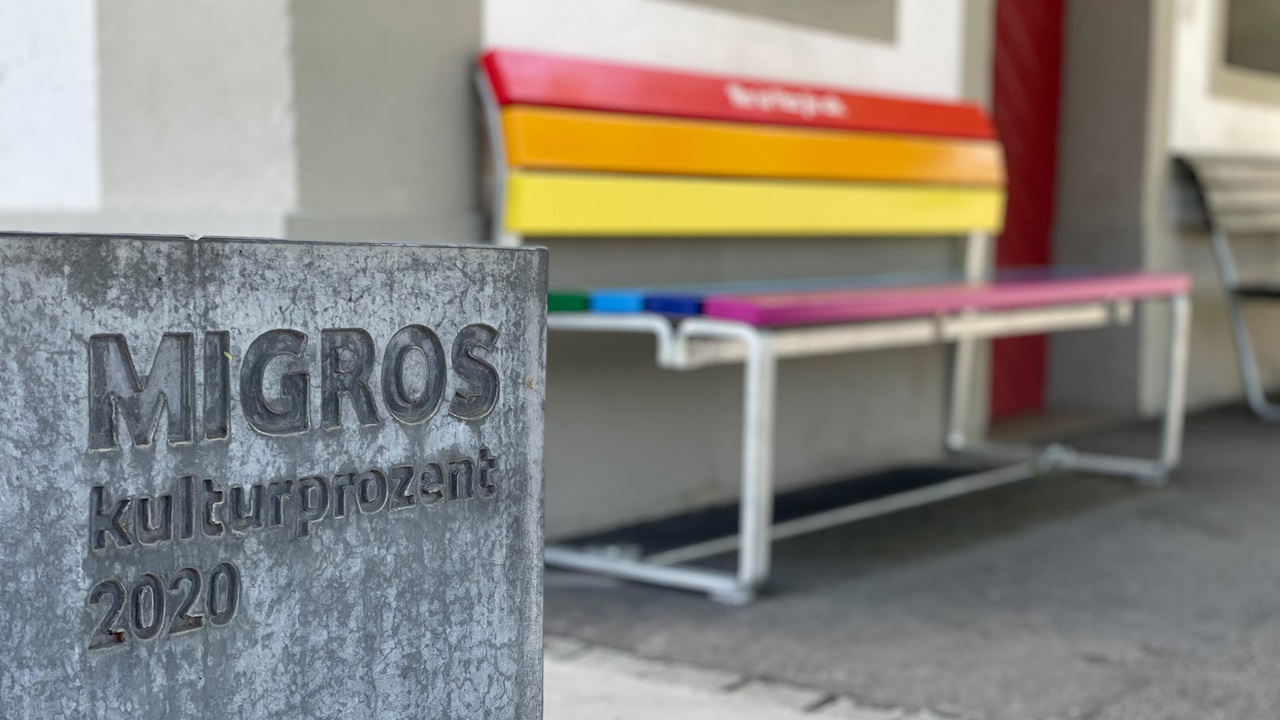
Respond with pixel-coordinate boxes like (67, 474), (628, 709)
(0, 0), (101, 210)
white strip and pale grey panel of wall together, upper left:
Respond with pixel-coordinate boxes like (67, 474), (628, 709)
(0, 0), (297, 236)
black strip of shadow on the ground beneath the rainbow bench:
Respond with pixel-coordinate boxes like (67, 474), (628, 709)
(564, 466), (974, 555)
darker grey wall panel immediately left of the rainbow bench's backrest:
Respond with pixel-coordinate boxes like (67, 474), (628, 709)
(289, 0), (481, 242)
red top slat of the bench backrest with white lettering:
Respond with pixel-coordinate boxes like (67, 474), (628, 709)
(480, 50), (996, 140)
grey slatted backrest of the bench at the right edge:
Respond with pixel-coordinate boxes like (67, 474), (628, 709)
(1179, 154), (1280, 236)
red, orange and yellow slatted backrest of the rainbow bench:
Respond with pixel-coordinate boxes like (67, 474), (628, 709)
(479, 51), (1005, 245)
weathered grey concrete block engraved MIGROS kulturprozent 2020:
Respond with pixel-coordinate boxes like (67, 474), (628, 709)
(0, 236), (547, 720)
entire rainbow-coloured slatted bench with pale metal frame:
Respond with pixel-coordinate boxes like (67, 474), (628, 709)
(477, 50), (1189, 602)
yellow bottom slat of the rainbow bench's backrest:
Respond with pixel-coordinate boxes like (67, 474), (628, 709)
(506, 170), (1005, 236)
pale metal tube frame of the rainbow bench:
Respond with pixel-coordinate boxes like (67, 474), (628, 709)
(475, 63), (1190, 605)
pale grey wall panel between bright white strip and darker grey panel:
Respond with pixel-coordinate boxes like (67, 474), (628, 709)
(99, 0), (297, 213)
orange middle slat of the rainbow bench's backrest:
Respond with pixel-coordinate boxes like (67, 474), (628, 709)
(503, 106), (1005, 184)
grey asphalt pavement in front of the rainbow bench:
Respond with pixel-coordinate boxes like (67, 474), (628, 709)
(545, 410), (1280, 720)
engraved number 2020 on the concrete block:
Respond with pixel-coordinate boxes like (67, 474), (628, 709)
(88, 562), (241, 650)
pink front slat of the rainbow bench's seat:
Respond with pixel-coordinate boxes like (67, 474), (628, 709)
(703, 273), (1190, 327)
